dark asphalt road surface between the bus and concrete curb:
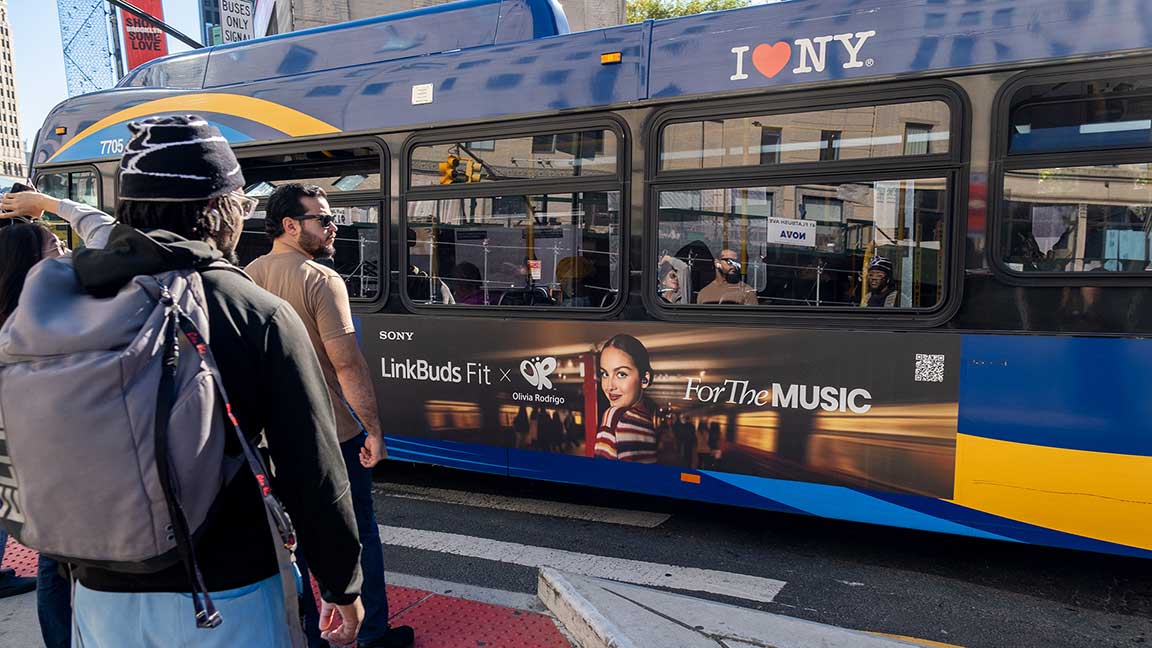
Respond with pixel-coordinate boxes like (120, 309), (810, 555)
(377, 462), (1152, 648)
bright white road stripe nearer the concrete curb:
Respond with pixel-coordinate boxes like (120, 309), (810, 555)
(380, 525), (785, 603)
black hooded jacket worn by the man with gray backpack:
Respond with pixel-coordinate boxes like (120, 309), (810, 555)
(74, 225), (361, 604)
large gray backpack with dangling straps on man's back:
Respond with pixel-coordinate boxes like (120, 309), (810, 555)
(0, 258), (298, 634)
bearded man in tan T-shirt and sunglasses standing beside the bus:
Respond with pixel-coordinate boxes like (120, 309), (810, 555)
(244, 182), (412, 648)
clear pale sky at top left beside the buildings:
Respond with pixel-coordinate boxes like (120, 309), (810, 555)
(8, 0), (200, 148)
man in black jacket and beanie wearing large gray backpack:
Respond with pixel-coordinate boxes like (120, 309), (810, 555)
(0, 115), (363, 648)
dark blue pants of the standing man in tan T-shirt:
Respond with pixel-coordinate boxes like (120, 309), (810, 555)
(296, 432), (388, 648)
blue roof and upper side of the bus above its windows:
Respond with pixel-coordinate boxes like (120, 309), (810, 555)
(33, 0), (1152, 165)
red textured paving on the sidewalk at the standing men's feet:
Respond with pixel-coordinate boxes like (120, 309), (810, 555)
(2, 540), (569, 648)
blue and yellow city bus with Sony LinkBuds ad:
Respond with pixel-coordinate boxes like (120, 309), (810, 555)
(24, 0), (1152, 557)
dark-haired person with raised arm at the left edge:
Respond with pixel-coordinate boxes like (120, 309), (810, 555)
(0, 189), (115, 648)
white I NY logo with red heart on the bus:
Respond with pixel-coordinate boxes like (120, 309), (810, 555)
(728, 30), (876, 81)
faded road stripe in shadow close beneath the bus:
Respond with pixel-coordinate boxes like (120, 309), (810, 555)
(377, 484), (672, 528)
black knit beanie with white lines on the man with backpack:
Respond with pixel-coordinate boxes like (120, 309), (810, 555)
(120, 115), (244, 202)
